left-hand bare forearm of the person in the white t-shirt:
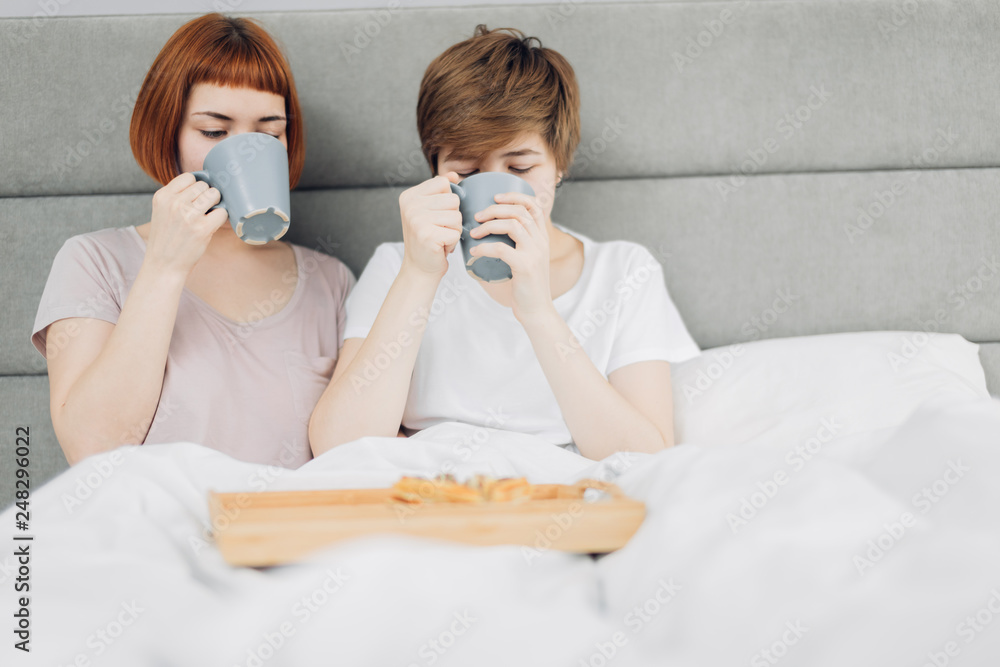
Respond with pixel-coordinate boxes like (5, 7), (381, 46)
(309, 266), (441, 456)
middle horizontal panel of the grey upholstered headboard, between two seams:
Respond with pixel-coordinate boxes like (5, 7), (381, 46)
(0, 169), (1000, 374)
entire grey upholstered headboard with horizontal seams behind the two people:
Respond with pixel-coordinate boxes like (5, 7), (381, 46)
(0, 0), (1000, 504)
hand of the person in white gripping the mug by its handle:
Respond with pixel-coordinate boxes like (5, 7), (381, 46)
(399, 171), (462, 278)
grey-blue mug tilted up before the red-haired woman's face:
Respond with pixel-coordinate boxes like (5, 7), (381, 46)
(194, 132), (291, 245)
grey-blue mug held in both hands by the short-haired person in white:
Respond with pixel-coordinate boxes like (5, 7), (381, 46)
(451, 171), (535, 282)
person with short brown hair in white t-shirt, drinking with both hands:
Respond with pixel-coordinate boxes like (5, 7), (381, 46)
(310, 26), (699, 459)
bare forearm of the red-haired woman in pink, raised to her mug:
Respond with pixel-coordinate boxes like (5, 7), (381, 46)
(52, 265), (185, 464)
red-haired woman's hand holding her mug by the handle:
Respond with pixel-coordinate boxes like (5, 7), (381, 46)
(144, 173), (229, 276)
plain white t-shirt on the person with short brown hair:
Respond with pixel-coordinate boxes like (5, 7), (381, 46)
(344, 225), (701, 445)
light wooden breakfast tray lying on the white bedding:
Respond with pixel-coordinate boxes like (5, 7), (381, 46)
(209, 480), (646, 567)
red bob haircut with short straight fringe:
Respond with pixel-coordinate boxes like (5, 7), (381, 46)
(129, 14), (306, 187)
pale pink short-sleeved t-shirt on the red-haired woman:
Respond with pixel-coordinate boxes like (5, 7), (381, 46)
(31, 227), (355, 468)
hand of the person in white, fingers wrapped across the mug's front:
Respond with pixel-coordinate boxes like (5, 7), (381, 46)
(469, 192), (553, 324)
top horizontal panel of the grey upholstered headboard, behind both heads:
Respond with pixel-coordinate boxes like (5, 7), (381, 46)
(0, 0), (1000, 196)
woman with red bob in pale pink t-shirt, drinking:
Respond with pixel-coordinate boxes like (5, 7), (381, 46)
(32, 14), (354, 467)
